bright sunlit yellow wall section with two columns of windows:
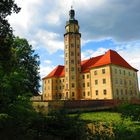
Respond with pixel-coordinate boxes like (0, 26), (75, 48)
(90, 65), (113, 99)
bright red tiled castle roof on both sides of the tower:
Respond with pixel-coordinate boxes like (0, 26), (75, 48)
(43, 50), (138, 79)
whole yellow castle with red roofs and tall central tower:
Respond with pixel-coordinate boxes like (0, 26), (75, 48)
(42, 9), (140, 100)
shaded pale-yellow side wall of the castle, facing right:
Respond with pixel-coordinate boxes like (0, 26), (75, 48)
(111, 65), (139, 100)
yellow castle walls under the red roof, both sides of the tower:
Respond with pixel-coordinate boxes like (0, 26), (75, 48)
(43, 65), (140, 100)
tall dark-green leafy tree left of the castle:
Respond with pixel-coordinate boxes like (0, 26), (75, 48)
(0, 0), (40, 110)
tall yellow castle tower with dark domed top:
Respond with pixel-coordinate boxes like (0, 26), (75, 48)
(64, 9), (81, 99)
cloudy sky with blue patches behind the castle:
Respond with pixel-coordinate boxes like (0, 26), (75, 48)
(9, 0), (140, 88)
